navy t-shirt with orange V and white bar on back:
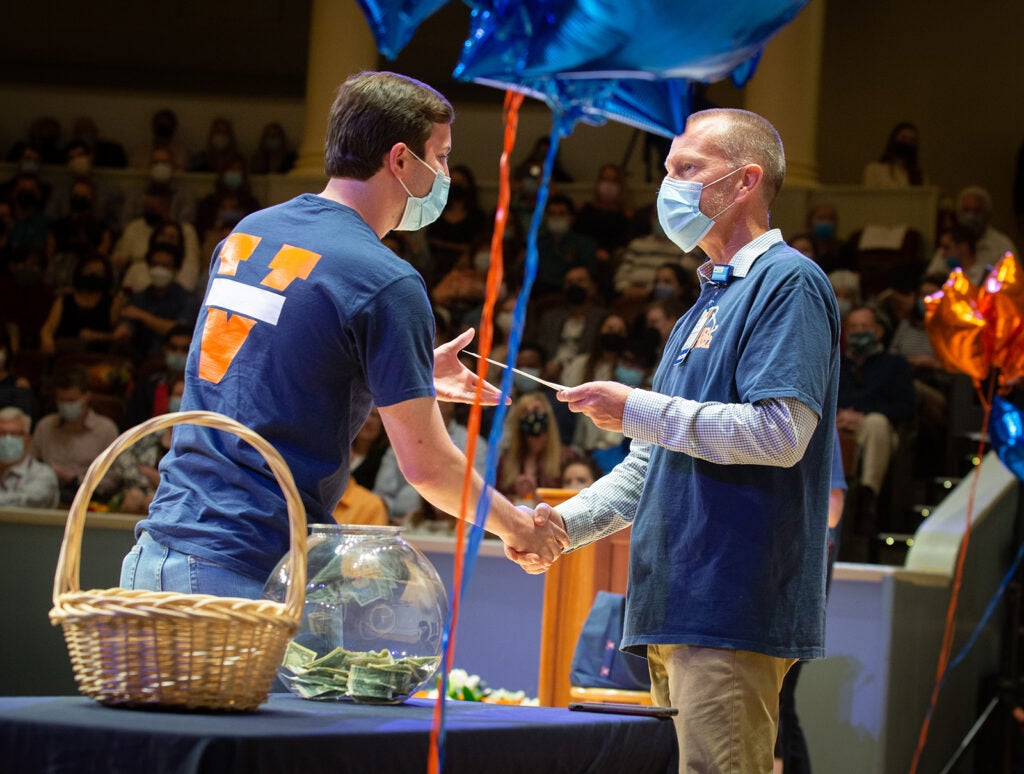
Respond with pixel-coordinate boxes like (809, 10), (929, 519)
(136, 194), (435, 578)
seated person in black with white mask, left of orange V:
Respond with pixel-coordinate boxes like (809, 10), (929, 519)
(114, 245), (199, 362)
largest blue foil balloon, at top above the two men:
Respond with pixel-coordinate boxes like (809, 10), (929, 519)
(455, 0), (807, 82)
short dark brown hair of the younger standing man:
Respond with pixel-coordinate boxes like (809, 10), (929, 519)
(324, 72), (455, 180)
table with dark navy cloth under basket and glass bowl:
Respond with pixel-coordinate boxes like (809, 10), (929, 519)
(0, 694), (677, 774)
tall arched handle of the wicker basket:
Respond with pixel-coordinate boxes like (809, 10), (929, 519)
(53, 412), (306, 620)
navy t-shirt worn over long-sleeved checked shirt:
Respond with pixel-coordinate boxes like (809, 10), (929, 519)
(623, 243), (839, 658)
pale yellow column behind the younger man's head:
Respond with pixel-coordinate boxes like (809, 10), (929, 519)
(292, 0), (377, 176)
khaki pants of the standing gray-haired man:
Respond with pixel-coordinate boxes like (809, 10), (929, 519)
(647, 645), (797, 774)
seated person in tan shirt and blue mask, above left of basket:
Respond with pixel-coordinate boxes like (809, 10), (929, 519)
(30, 367), (118, 505)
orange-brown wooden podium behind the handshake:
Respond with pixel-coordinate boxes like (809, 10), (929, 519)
(538, 488), (631, 706)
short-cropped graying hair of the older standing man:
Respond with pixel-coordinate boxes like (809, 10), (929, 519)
(686, 108), (785, 205)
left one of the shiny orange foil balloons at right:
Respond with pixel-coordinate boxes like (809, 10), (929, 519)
(925, 268), (989, 381)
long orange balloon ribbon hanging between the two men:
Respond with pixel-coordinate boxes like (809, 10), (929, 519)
(427, 91), (523, 774)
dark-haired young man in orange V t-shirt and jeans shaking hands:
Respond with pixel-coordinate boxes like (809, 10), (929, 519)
(121, 72), (565, 599)
